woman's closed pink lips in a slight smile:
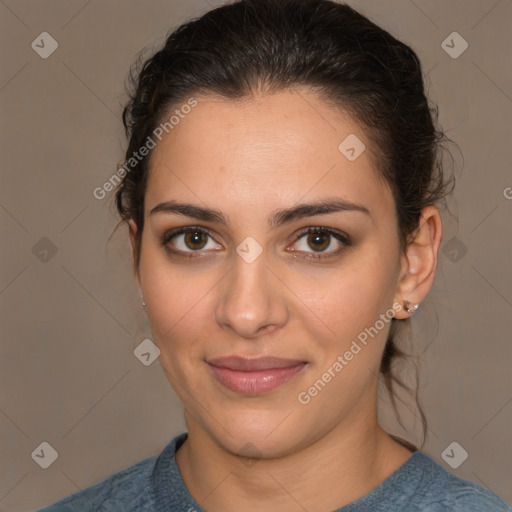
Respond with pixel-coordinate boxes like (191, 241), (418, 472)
(207, 356), (307, 395)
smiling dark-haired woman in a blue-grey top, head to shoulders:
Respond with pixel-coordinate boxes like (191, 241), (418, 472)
(38, 0), (510, 512)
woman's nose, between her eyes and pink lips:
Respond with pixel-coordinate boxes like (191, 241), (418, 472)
(215, 250), (289, 338)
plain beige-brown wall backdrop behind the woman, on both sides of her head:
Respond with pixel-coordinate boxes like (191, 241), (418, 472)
(0, 0), (512, 512)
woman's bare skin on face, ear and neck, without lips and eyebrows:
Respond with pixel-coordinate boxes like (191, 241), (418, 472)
(130, 89), (442, 512)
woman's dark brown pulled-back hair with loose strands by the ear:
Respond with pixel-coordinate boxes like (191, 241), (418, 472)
(116, 0), (454, 445)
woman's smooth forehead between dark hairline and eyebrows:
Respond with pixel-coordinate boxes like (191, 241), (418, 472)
(146, 90), (393, 222)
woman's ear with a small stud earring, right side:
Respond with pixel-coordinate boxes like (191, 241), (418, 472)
(395, 206), (443, 319)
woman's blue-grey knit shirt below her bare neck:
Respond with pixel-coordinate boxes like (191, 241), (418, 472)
(37, 432), (512, 512)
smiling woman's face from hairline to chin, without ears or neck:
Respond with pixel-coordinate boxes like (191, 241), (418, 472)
(132, 89), (408, 457)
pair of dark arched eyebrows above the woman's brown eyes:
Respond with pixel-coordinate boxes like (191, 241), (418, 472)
(149, 197), (371, 229)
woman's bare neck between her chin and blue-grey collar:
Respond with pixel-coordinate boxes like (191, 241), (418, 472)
(176, 406), (411, 512)
